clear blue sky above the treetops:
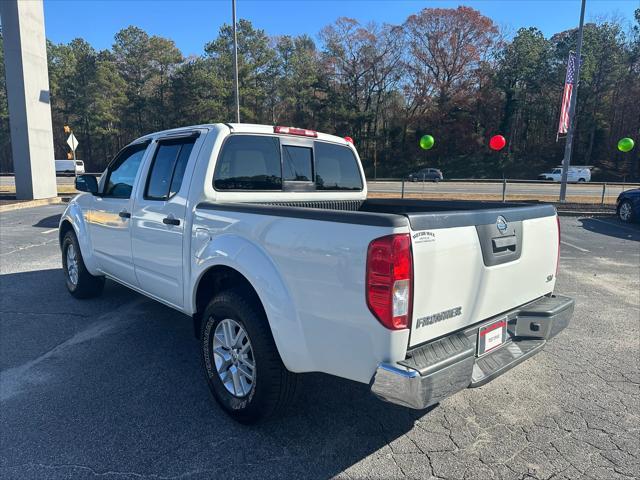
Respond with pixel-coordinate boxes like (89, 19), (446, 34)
(44, 0), (640, 55)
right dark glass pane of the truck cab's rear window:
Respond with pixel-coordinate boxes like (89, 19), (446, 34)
(315, 142), (362, 190)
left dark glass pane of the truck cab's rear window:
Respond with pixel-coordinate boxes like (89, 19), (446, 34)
(213, 135), (282, 190)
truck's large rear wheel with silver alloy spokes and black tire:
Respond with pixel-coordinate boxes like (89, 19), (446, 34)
(200, 289), (298, 424)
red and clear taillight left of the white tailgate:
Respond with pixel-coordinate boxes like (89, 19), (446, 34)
(367, 233), (413, 330)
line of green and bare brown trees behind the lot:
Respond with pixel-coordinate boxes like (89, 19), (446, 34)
(0, 6), (640, 180)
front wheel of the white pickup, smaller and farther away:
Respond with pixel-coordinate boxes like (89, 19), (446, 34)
(62, 230), (104, 298)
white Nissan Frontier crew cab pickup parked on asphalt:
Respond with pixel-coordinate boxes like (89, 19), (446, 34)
(60, 124), (573, 423)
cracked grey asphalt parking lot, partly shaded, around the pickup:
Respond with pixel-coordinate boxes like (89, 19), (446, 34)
(0, 206), (640, 479)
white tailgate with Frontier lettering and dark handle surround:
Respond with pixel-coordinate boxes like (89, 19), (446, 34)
(406, 205), (559, 347)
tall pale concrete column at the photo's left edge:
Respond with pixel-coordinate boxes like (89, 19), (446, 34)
(0, 0), (58, 200)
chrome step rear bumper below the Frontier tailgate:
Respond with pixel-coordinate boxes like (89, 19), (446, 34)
(371, 295), (574, 409)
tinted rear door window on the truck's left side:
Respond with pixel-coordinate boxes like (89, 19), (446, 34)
(144, 137), (195, 200)
